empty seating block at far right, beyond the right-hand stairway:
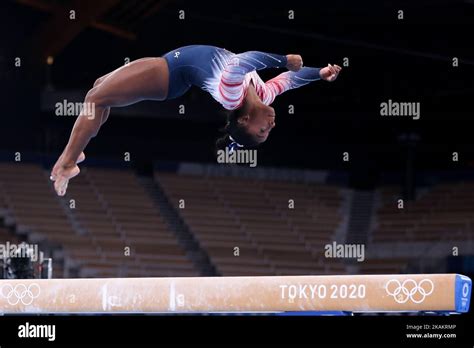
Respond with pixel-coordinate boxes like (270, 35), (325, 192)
(372, 182), (474, 242)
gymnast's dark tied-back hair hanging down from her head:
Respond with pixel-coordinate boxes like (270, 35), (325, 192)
(215, 108), (259, 154)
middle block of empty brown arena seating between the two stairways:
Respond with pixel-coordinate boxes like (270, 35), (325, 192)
(156, 173), (344, 276)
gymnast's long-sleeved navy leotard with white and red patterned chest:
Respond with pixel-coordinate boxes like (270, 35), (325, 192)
(163, 45), (321, 110)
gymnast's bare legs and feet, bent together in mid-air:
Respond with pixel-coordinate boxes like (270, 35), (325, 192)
(51, 58), (169, 196)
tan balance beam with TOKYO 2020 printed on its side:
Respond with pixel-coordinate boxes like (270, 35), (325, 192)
(0, 274), (472, 314)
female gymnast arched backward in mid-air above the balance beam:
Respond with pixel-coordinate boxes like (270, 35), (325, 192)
(51, 45), (341, 196)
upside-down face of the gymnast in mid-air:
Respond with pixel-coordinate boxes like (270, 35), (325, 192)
(239, 102), (275, 144)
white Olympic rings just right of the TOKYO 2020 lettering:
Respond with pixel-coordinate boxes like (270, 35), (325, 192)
(385, 279), (434, 303)
